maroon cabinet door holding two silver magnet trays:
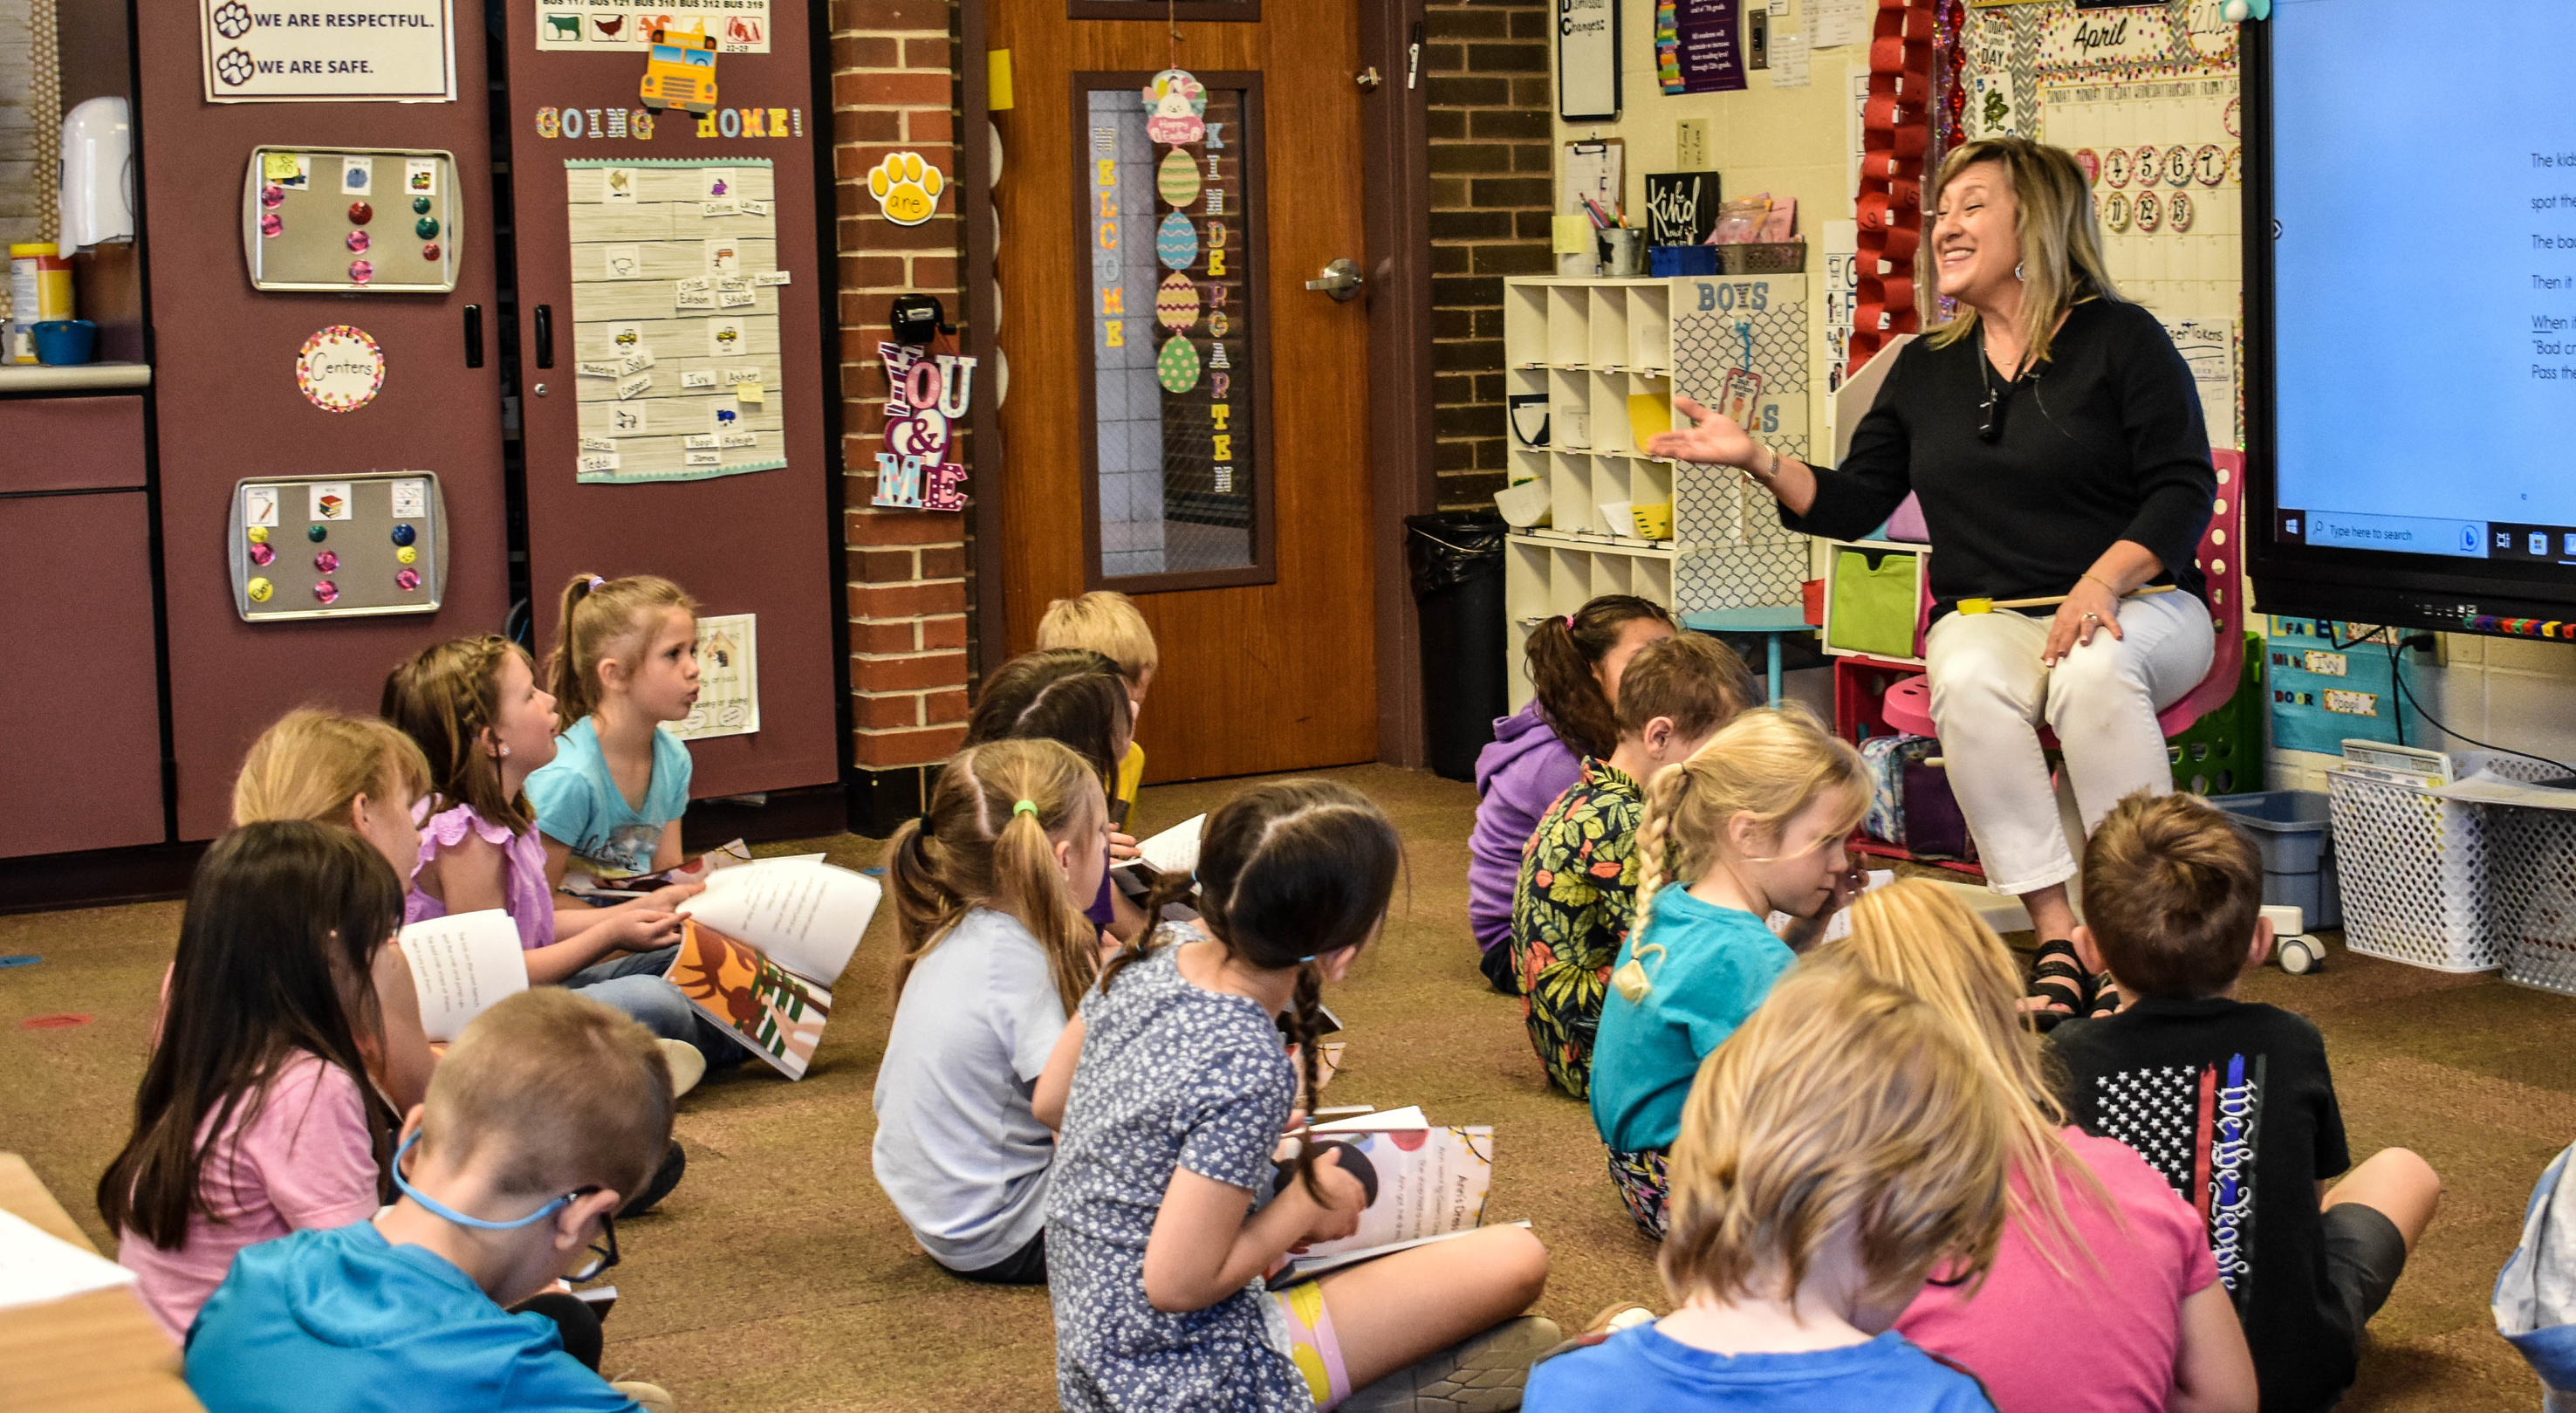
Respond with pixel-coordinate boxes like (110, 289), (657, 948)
(134, 0), (510, 838)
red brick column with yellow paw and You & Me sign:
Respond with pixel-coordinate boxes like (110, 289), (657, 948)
(832, 0), (971, 833)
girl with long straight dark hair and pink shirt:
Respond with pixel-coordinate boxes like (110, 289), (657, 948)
(98, 820), (402, 1338)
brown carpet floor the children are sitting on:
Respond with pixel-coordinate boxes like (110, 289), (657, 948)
(0, 765), (2576, 1413)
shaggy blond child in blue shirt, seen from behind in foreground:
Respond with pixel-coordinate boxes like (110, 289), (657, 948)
(1523, 957), (2009, 1413)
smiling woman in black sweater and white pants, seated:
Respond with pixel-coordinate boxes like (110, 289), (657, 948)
(1648, 137), (2218, 974)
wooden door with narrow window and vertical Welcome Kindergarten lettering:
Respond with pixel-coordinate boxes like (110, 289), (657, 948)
(990, 0), (1378, 781)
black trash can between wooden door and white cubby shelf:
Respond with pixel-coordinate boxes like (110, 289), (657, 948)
(1404, 511), (1512, 781)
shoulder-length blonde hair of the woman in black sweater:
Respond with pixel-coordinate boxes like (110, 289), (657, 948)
(1914, 137), (2122, 367)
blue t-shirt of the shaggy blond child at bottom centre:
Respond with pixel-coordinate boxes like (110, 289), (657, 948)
(1520, 1326), (1994, 1413)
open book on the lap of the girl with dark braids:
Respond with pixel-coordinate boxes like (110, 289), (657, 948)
(1270, 1108), (1494, 1289)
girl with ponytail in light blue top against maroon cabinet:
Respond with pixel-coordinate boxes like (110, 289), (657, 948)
(528, 575), (698, 887)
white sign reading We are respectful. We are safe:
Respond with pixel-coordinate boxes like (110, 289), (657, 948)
(198, 0), (456, 103)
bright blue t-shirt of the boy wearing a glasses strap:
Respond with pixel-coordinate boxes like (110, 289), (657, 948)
(188, 1222), (636, 1413)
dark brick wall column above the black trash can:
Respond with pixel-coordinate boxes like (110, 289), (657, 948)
(1422, 0), (1556, 508)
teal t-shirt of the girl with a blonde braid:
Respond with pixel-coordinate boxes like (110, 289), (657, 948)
(1592, 884), (1798, 1153)
